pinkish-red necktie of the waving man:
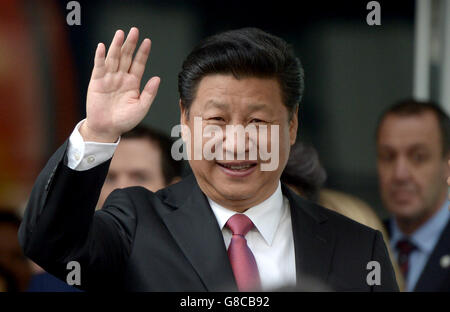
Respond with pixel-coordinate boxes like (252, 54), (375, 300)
(226, 214), (261, 291)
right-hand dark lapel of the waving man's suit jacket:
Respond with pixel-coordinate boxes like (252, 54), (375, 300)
(282, 185), (335, 289)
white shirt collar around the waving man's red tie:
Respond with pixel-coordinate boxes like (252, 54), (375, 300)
(208, 182), (283, 246)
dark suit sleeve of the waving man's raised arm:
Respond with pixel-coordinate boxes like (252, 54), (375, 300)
(19, 141), (136, 290)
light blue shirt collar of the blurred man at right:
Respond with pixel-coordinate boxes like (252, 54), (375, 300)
(391, 200), (450, 252)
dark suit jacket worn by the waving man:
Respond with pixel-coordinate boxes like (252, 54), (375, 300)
(19, 141), (398, 291)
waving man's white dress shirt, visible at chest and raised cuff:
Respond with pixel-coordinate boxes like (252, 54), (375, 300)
(66, 120), (296, 290)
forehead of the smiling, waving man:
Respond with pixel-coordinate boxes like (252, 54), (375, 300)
(192, 74), (284, 110)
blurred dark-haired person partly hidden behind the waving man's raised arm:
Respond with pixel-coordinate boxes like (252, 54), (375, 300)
(97, 125), (182, 208)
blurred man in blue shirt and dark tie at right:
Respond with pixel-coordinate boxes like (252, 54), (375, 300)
(376, 99), (450, 291)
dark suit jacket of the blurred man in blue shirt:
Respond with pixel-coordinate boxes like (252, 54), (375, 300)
(384, 220), (450, 292)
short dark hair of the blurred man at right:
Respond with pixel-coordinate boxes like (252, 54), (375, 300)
(376, 99), (450, 156)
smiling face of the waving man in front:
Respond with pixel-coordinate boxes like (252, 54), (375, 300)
(181, 74), (297, 211)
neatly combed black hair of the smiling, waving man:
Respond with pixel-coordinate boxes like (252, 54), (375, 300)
(178, 28), (304, 119)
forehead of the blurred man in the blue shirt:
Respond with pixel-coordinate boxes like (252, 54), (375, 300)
(377, 112), (441, 149)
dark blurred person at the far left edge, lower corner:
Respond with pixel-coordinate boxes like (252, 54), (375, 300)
(0, 208), (31, 291)
